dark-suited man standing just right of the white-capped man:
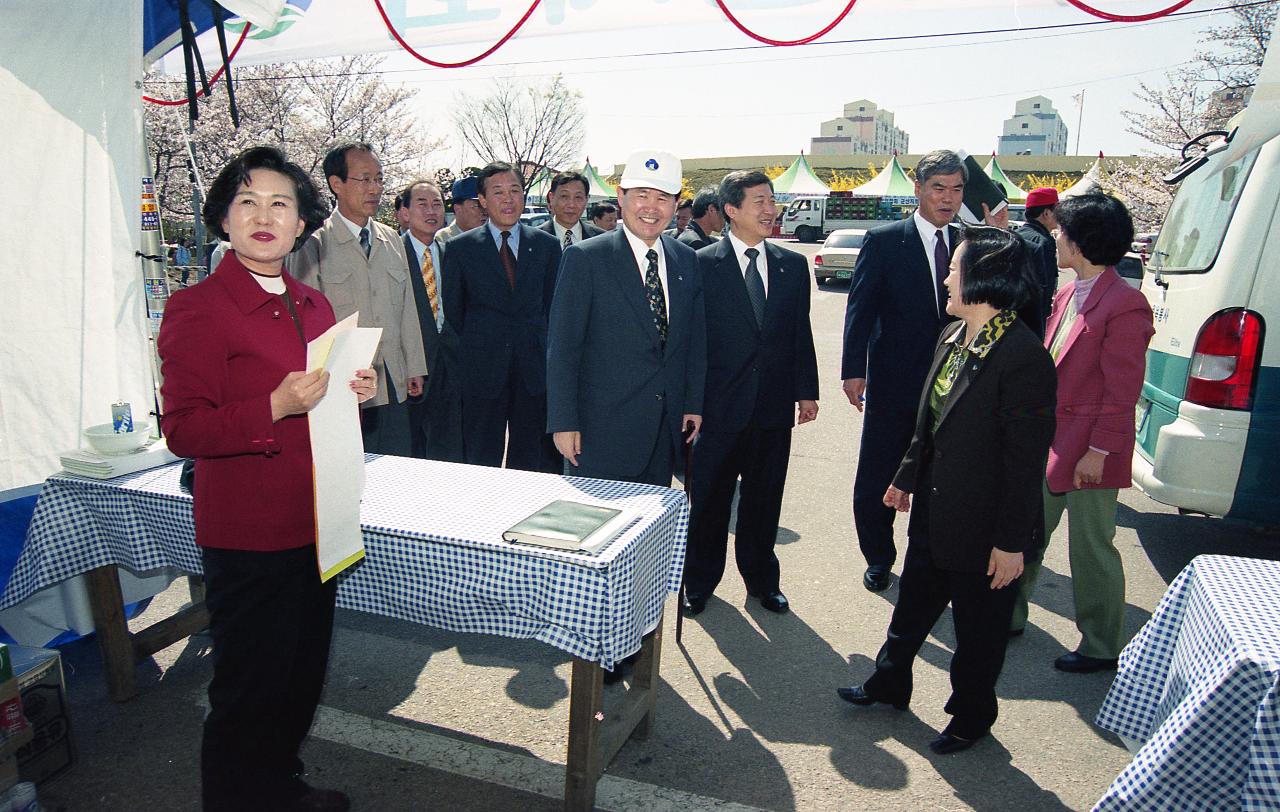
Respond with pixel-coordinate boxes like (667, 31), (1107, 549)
(685, 172), (818, 615)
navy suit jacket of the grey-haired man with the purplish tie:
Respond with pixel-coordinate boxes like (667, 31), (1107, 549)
(840, 218), (960, 414)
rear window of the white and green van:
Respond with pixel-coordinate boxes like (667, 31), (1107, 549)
(1147, 150), (1258, 273)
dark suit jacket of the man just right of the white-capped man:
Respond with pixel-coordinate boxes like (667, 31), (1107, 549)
(701, 236), (818, 432)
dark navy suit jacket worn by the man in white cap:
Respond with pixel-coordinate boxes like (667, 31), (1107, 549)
(547, 229), (707, 478)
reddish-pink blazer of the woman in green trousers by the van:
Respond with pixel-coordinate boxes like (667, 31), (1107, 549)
(1044, 268), (1156, 493)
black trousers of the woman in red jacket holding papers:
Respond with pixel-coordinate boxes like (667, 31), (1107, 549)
(200, 547), (337, 812)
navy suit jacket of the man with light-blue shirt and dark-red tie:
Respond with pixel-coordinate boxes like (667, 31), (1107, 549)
(440, 224), (561, 398)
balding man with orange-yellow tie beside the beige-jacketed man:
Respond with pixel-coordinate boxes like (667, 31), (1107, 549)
(398, 181), (466, 462)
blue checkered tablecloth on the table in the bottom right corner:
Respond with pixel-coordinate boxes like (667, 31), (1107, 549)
(1094, 556), (1280, 812)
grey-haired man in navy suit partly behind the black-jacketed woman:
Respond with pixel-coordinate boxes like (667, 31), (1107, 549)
(840, 150), (968, 592)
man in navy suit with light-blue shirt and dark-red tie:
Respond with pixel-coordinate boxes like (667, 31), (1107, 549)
(442, 161), (561, 471)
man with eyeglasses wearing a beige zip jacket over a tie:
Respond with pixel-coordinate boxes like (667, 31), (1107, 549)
(287, 142), (426, 457)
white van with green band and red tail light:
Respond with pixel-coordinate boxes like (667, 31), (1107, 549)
(1133, 121), (1280, 526)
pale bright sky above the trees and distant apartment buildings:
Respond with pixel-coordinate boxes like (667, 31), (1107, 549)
(385, 0), (1226, 166)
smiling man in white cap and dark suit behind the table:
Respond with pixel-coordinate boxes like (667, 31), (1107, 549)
(547, 150), (707, 485)
